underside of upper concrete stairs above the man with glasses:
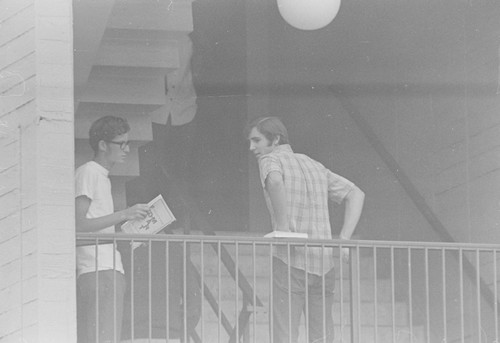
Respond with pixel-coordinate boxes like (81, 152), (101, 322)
(73, 0), (193, 181)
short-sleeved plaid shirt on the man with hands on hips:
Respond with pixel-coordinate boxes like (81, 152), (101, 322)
(259, 144), (354, 275)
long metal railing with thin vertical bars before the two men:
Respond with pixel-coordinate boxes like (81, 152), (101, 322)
(77, 233), (500, 343)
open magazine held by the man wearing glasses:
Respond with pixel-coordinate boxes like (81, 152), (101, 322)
(121, 194), (176, 249)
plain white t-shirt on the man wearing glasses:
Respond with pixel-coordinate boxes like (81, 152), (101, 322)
(75, 161), (124, 276)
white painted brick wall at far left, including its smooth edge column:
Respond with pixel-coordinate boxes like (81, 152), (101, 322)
(0, 0), (76, 343)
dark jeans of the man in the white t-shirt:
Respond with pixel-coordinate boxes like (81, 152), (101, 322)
(76, 270), (127, 343)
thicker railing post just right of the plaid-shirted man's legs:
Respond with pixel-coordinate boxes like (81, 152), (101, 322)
(350, 248), (361, 343)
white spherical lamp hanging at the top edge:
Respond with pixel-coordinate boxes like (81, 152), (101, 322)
(278, 0), (340, 30)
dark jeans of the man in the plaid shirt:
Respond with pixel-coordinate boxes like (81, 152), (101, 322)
(272, 258), (335, 343)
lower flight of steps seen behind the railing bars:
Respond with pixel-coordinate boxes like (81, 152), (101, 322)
(191, 239), (425, 343)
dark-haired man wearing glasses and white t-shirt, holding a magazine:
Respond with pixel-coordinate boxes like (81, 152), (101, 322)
(75, 116), (148, 343)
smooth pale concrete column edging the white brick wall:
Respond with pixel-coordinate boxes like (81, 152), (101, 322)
(32, 0), (76, 343)
